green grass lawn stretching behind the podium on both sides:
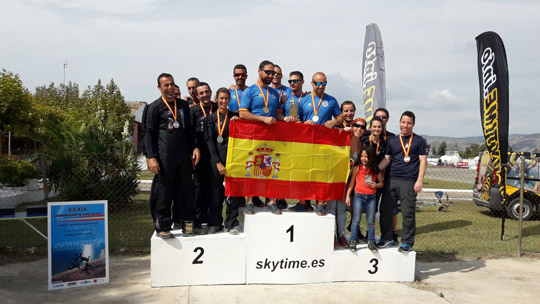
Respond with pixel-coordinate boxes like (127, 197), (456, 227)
(0, 193), (540, 265)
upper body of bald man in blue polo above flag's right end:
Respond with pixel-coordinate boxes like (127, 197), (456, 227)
(300, 72), (343, 129)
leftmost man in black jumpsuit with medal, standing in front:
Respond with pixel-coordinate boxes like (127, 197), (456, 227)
(144, 73), (200, 238)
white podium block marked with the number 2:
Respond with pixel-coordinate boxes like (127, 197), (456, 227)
(150, 230), (246, 287)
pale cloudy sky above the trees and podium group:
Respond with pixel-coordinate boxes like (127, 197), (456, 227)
(0, 0), (540, 137)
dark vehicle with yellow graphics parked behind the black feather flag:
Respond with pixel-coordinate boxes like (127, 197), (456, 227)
(473, 151), (540, 221)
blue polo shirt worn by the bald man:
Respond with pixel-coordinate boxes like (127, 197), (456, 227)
(299, 94), (341, 125)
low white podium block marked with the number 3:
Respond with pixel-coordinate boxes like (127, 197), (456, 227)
(332, 244), (416, 282)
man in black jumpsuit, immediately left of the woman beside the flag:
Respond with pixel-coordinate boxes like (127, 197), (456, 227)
(189, 82), (217, 233)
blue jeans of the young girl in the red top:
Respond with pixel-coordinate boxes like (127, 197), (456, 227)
(351, 192), (377, 242)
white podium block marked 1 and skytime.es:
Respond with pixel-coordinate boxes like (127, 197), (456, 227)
(244, 211), (335, 284)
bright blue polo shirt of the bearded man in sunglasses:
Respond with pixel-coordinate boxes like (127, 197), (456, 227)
(239, 84), (281, 119)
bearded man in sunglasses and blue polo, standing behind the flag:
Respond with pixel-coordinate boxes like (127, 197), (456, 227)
(239, 60), (296, 214)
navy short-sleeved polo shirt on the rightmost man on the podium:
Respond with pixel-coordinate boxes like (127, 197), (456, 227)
(386, 133), (428, 181)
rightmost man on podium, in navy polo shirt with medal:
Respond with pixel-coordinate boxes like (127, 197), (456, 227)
(377, 111), (428, 252)
